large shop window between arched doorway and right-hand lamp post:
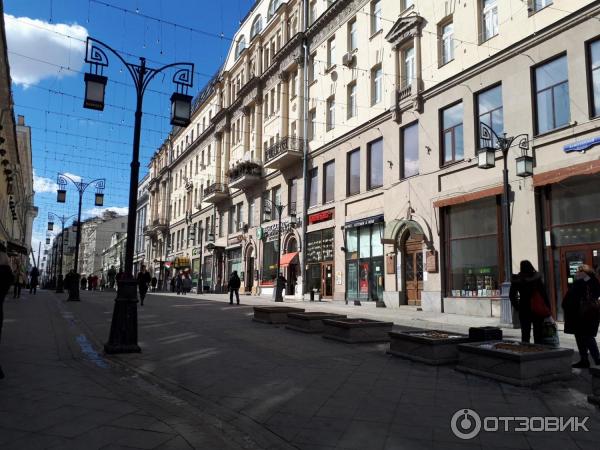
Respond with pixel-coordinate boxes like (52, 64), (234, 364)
(445, 197), (502, 297)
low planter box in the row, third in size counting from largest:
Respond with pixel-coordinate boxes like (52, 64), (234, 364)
(323, 319), (394, 344)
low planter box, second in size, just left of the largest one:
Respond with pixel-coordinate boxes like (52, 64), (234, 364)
(388, 330), (469, 365)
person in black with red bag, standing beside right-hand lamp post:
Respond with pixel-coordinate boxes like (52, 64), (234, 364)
(509, 260), (552, 344)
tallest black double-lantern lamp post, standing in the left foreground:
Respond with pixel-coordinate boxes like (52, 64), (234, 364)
(83, 37), (194, 353)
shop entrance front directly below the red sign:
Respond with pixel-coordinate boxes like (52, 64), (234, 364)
(306, 228), (335, 298)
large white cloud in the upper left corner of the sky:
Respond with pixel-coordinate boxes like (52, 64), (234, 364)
(4, 14), (88, 86)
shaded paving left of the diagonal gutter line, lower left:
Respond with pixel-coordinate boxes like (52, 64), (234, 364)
(0, 291), (292, 450)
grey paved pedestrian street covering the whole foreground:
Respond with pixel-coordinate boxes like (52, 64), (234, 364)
(0, 292), (600, 450)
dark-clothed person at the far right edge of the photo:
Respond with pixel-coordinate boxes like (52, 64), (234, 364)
(562, 264), (600, 369)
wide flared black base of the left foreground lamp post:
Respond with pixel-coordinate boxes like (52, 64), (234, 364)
(104, 280), (142, 355)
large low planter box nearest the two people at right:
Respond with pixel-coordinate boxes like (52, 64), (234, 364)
(456, 341), (573, 386)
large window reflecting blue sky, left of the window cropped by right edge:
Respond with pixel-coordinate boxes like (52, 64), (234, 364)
(535, 56), (571, 133)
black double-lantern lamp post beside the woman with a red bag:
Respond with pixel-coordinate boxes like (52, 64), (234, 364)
(477, 122), (533, 326)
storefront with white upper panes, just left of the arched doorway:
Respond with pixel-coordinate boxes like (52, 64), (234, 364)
(344, 215), (384, 302)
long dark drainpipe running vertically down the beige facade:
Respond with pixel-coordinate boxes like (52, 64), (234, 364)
(301, 0), (309, 299)
